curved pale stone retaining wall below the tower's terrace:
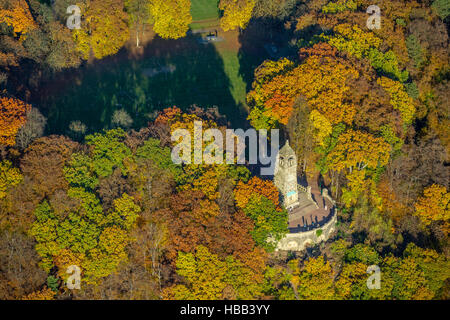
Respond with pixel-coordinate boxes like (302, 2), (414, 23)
(275, 210), (337, 251)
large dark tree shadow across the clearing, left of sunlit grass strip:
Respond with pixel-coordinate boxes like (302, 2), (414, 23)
(40, 35), (246, 134)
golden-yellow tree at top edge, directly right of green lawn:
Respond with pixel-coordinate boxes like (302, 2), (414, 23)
(219, 0), (256, 31)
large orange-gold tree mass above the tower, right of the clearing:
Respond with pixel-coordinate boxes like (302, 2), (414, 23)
(247, 51), (359, 125)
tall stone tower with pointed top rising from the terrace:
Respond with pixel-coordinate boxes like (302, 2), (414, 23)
(274, 140), (299, 209)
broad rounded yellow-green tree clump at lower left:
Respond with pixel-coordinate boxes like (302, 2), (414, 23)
(29, 188), (140, 284)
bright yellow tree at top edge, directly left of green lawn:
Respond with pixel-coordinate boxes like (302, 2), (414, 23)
(150, 0), (192, 39)
